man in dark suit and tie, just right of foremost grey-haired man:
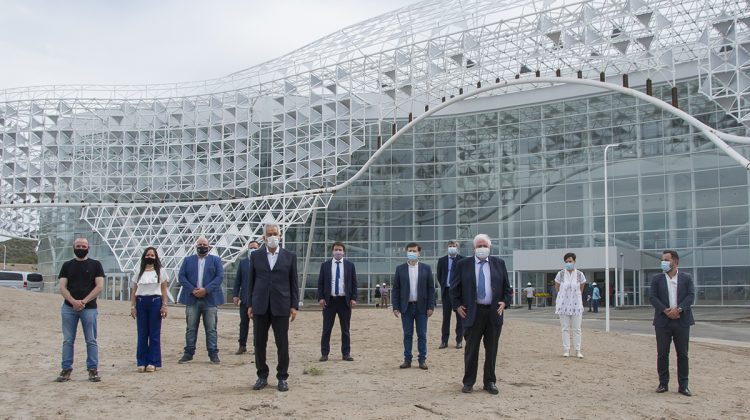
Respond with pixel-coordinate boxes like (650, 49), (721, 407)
(317, 242), (357, 362)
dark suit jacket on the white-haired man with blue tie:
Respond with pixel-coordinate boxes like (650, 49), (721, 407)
(450, 256), (511, 328)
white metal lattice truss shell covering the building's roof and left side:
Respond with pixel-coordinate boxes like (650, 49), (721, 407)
(0, 0), (750, 270)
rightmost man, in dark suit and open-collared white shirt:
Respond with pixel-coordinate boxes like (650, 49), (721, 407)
(650, 250), (695, 397)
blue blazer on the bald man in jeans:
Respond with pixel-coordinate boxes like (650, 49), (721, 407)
(178, 254), (224, 306)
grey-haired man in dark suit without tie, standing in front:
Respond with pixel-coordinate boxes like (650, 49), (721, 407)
(246, 223), (299, 392)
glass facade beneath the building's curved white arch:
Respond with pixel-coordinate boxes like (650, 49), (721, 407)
(285, 80), (750, 305)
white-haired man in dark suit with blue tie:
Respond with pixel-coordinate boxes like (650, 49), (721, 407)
(450, 234), (511, 394)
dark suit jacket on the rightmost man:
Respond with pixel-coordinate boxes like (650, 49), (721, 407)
(649, 270), (695, 327)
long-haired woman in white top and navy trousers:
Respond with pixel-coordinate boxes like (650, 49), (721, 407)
(130, 247), (167, 372)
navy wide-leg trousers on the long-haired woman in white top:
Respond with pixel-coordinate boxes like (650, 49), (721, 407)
(135, 295), (162, 367)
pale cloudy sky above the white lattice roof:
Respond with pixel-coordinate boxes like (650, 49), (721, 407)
(0, 0), (415, 90)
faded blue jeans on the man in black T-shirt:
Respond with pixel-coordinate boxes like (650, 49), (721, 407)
(60, 303), (99, 370)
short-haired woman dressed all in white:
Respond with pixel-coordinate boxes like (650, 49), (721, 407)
(555, 252), (586, 359)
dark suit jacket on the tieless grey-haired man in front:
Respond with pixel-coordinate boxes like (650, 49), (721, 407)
(245, 245), (299, 316)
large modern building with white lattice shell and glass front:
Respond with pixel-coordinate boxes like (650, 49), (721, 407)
(0, 0), (750, 305)
